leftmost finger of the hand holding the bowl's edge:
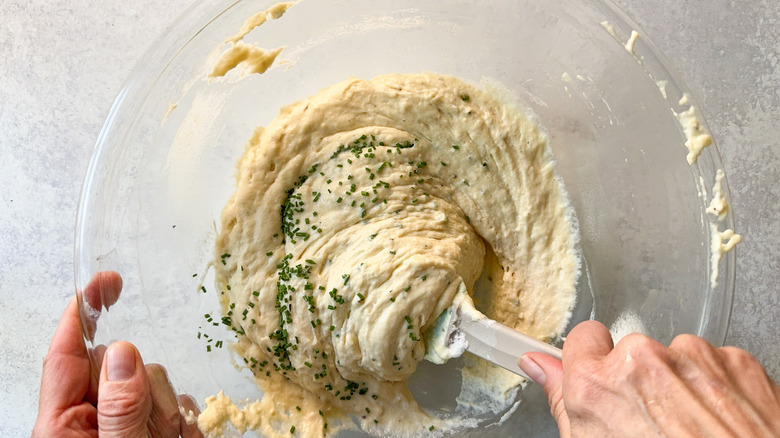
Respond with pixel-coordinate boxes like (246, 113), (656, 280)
(38, 297), (89, 416)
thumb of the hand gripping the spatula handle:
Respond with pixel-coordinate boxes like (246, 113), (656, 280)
(518, 353), (569, 437)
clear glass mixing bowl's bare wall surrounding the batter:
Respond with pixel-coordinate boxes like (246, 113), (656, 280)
(75, 0), (735, 436)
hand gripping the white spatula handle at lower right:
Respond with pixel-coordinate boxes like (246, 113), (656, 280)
(519, 321), (780, 438)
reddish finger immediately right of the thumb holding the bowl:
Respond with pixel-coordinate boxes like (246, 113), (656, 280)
(146, 364), (180, 438)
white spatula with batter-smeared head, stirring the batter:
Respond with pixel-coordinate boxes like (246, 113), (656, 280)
(438, 306), (561, 377)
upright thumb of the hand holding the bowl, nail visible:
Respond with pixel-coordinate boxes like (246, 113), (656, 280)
(98, 342), (152, 438)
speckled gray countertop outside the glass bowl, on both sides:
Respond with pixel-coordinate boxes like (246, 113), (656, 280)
(0, 0), (780, 437)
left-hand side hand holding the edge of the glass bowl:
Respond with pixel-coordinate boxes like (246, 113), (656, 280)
(32, 272), (202, 438)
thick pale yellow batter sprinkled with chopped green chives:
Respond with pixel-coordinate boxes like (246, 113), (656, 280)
(200, 74), (579, 437)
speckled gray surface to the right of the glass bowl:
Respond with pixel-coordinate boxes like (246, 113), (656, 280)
(616, 0), (780, 379)
